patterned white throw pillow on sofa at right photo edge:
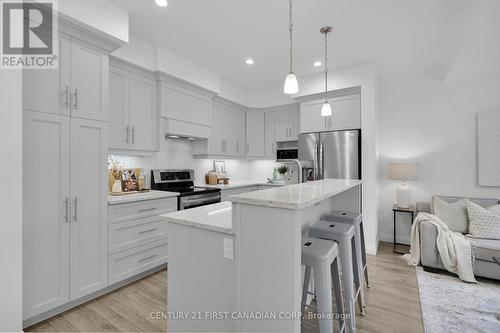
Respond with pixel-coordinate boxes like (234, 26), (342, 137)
(467, 202), (500, 239)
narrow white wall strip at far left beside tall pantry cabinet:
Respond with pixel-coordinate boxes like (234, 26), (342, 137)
(0, 70), (23, 332)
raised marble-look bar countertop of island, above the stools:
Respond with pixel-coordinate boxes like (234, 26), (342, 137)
(229, 179), (362, 209)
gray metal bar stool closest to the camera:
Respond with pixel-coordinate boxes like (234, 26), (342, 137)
(301, 237), (345, 333)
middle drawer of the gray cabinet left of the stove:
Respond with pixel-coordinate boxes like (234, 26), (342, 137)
(109, 216), (167, 253)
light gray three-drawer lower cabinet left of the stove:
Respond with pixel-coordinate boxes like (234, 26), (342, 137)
(108, 197), (177, 285)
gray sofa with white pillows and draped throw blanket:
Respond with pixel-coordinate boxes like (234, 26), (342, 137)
(417, 196), (500, 280)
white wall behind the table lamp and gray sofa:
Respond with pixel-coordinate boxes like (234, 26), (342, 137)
(379, 73), (500, 242)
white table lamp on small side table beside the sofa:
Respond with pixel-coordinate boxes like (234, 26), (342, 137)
(387, 162), (418, 208)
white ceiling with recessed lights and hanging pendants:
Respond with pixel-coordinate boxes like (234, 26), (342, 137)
(113, 0), (481, 92)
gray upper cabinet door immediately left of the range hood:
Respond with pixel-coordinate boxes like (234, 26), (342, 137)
(130, 74), (158, 151)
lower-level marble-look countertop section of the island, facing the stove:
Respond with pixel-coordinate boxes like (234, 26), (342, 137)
(160, 202), (234, 235)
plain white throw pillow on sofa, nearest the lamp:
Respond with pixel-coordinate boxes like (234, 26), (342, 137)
(432, 197), (469, 234)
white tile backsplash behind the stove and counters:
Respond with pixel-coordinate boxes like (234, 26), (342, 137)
(113, 139), (276, 187)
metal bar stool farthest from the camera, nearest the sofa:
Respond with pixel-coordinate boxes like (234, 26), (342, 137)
(324, 210), (370, 288)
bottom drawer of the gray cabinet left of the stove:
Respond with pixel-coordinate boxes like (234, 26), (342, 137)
(109, 240), (167, 285)
